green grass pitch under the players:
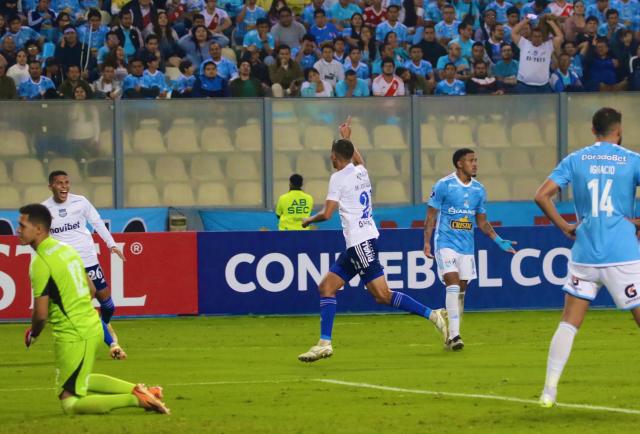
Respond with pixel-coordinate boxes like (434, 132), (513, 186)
(0, 311), (640, 434)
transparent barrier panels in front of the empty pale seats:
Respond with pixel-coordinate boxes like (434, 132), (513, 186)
(0, 93), (640, 209)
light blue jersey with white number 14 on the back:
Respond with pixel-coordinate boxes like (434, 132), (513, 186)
(549, 142), (640, 266)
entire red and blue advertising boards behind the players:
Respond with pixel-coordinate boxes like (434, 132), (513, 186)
(0, 226), (613, 320)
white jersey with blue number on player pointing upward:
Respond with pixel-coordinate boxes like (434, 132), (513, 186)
(327, 163), (380, 248)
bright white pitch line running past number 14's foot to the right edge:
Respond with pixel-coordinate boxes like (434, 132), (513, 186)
(314, 378), (640, 415)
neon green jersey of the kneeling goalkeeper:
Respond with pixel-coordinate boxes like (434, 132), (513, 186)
(29, 237), (103, 341)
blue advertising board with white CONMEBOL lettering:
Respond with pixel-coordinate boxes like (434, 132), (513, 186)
(198, 226), (613, 314)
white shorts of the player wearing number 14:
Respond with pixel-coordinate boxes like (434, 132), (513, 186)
(562, 262), (640, 310)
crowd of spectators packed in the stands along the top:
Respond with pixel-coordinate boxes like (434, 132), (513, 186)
(0, 0), (640, 99)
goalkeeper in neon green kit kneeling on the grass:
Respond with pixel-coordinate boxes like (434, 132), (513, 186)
(18, 204), (169, 414)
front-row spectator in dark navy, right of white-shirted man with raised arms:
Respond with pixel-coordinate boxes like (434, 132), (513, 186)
(585, 37), (627, 92)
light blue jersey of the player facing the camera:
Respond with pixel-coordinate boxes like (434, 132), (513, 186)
(428, 173), (487, 255)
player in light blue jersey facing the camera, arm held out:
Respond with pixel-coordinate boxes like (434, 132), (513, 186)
(424, 148), (516, 351)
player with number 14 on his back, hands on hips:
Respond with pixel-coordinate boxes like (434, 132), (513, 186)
(535, 108), (640, 407)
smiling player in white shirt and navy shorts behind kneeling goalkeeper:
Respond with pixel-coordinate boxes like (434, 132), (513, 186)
(42, 170), (124, 345)
